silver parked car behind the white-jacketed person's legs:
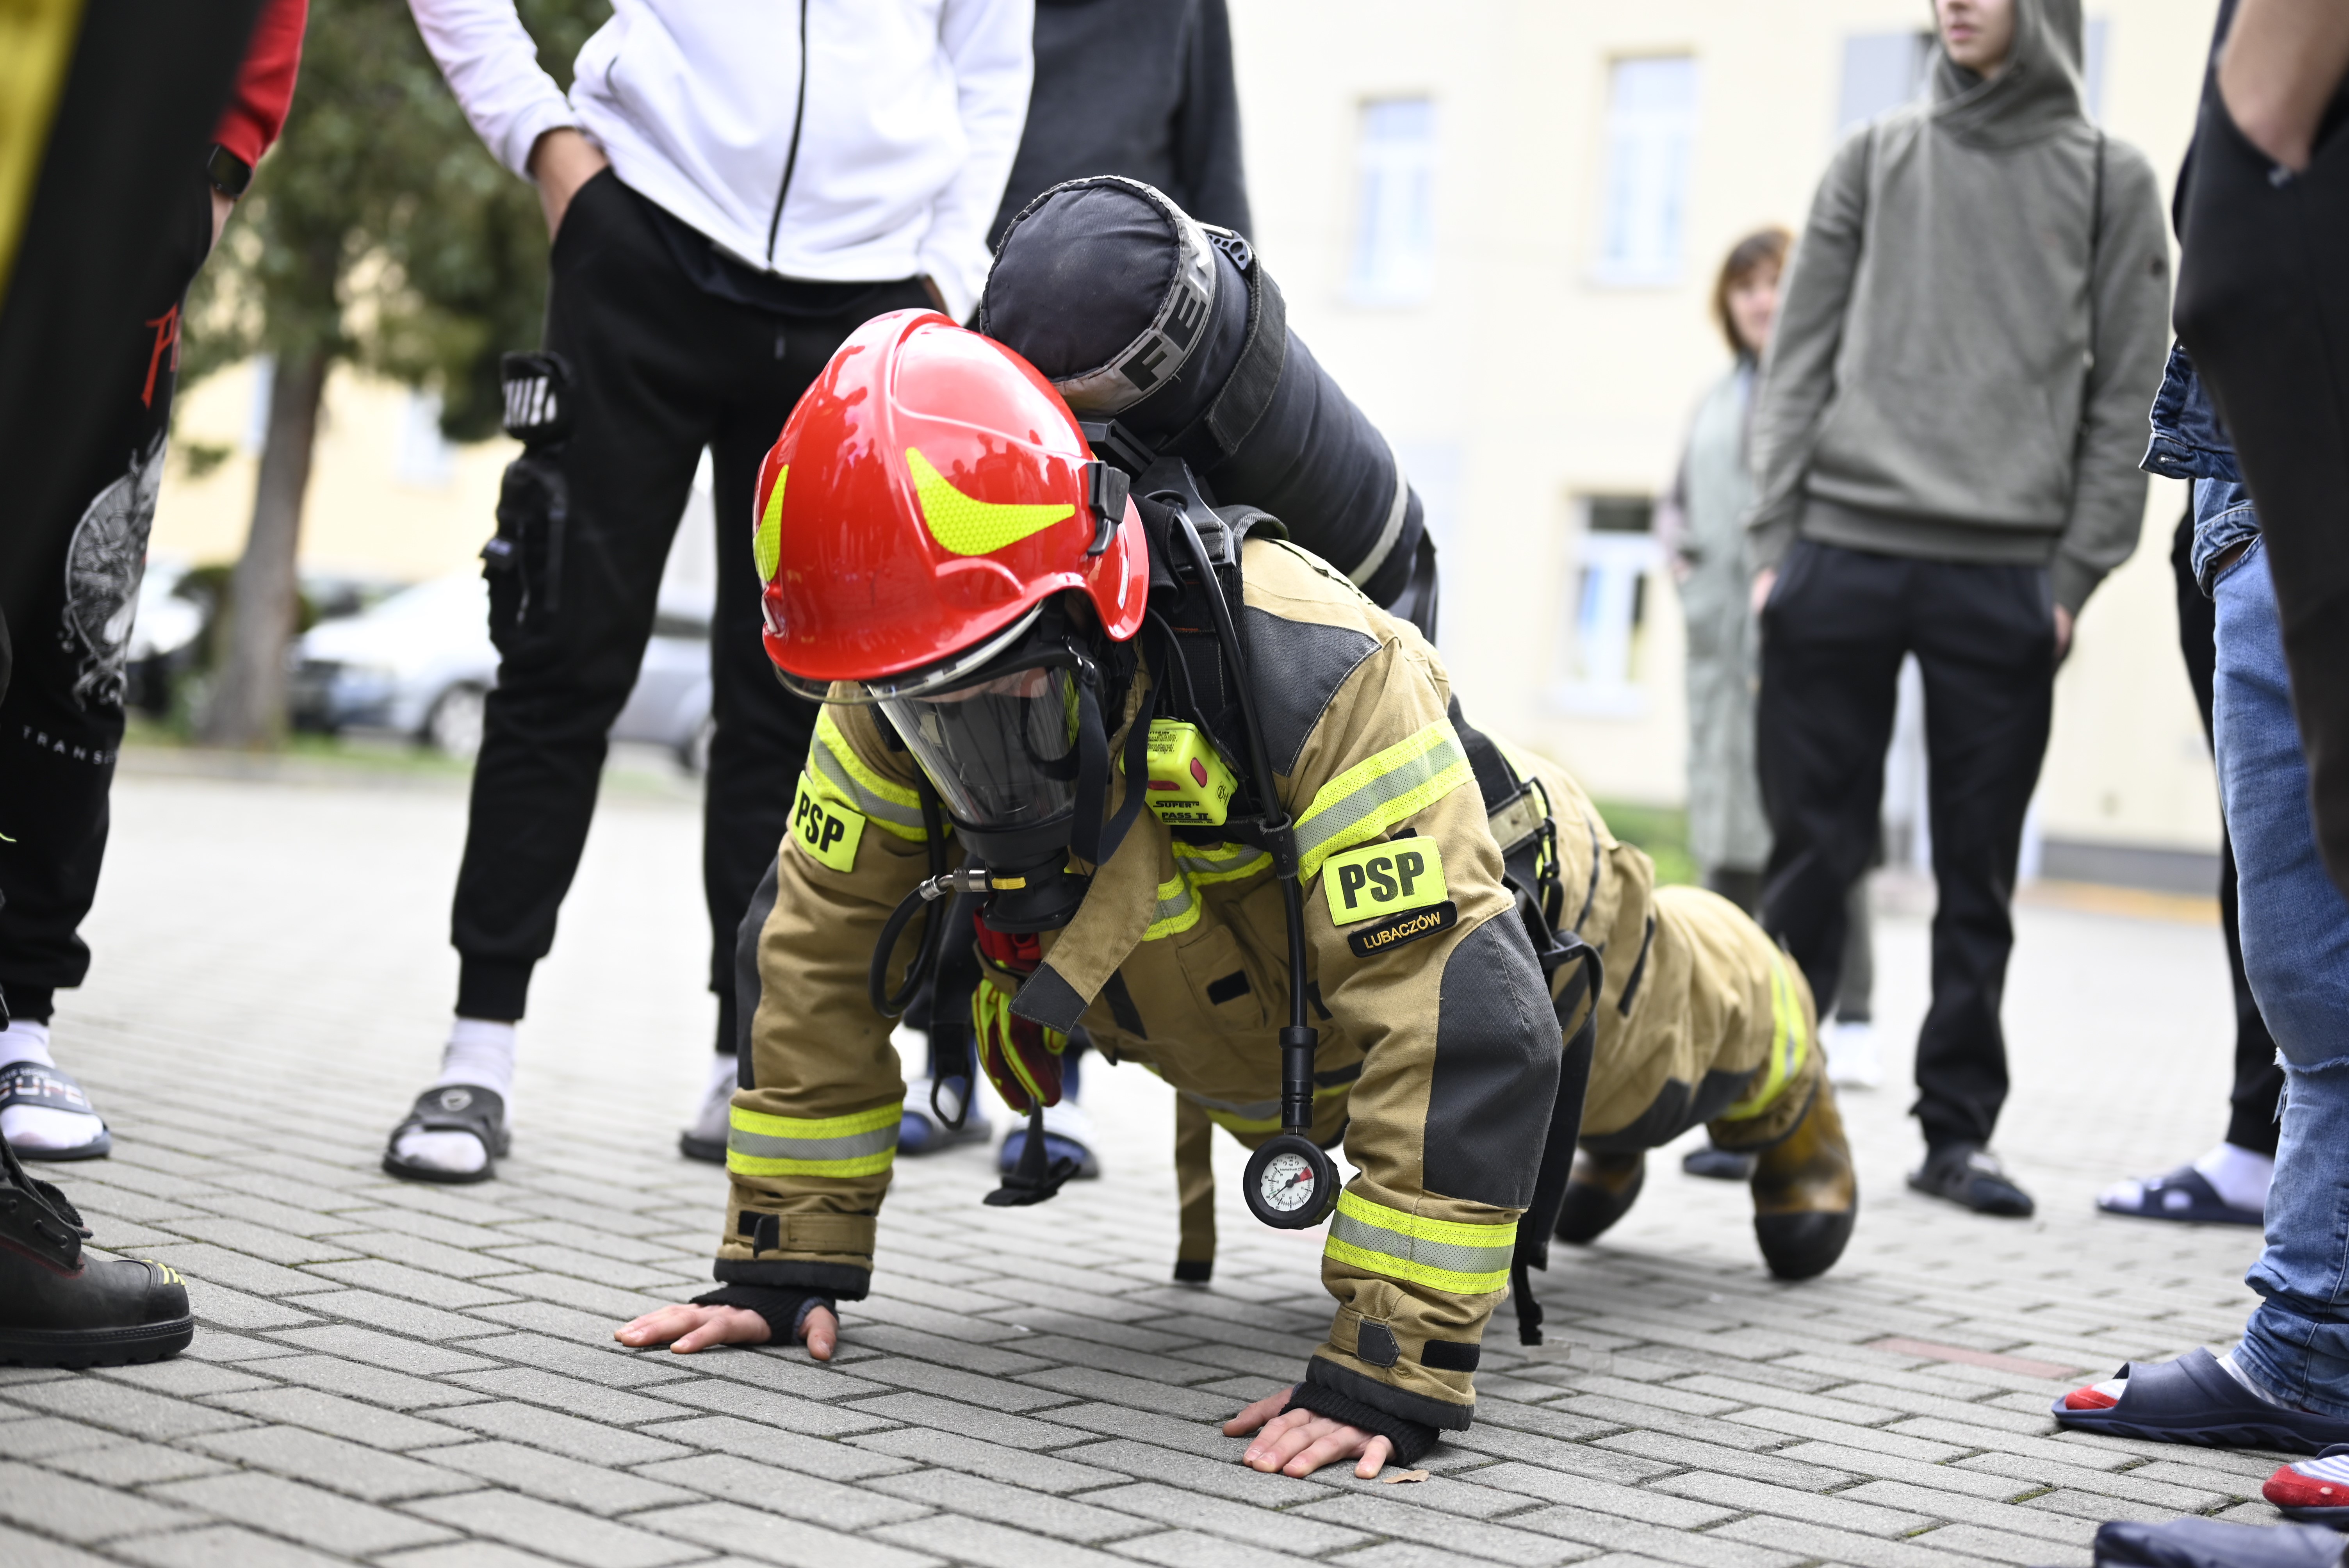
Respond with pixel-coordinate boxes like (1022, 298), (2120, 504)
(291, 570), (709, 772)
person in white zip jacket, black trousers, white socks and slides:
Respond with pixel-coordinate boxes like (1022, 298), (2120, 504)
(383, 0), (1034, 1181)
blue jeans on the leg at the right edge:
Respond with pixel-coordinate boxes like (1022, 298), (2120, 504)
(2213, 540), (2349, 1420)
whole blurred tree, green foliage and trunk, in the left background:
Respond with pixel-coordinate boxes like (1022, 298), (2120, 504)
(181, 0), (611, 747)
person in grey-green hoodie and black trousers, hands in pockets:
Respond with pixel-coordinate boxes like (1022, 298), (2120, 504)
(1748, 0), (2168, 1216)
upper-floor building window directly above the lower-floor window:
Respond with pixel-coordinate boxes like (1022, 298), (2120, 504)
(1595, 54), (1696, 286)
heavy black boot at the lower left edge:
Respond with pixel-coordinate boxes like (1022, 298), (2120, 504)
(0, 1141), (195, 1368)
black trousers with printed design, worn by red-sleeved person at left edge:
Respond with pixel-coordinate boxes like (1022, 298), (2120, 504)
(0, 177), (211, 1023)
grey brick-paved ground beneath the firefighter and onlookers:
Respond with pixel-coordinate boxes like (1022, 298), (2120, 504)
(0, 765), (2302, 1568)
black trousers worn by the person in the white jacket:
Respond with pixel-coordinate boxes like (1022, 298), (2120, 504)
(451, 171), (928, 1051)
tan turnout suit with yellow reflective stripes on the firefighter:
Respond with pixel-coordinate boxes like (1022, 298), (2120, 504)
(719, 540), (1816, 1429)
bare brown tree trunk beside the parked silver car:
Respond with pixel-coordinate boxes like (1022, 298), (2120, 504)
(200, 347), (331, 747)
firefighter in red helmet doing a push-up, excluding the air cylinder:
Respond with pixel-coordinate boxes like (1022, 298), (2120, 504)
(620, 312), (1856, 1474)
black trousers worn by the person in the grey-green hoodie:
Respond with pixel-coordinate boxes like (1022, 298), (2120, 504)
(1757, 540), (2055, 1146)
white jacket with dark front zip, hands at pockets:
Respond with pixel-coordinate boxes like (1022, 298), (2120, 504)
(409, 0), (1034, 319)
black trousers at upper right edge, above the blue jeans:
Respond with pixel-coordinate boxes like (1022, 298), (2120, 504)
(2175, 82), (2349, 892)
